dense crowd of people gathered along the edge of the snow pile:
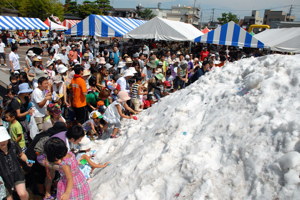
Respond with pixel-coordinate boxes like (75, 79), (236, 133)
(0, 35), (262, 200)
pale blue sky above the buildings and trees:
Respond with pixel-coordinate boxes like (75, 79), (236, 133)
(60, 0), (300, 22)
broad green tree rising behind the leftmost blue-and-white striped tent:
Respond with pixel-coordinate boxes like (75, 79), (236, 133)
(19, 0), (64, 20)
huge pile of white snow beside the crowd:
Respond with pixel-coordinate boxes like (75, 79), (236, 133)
(90, 55), (300, 200)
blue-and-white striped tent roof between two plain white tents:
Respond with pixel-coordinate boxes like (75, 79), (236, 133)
(195, 21), (264, 48)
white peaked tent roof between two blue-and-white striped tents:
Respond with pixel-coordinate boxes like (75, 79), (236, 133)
(124, 17), (203, 41)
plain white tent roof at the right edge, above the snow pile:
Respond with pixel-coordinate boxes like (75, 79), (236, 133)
(254, 28), (300, 53)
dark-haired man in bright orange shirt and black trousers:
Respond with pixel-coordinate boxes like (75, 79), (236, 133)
(71, 65), (88, 125)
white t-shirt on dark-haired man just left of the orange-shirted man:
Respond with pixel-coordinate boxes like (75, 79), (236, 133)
(31, 88), (49, 117)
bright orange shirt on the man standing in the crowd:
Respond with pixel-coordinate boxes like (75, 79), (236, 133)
(71, 74), (87, 108)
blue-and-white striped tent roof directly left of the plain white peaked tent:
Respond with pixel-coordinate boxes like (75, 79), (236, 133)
(65, 14), (147, 37)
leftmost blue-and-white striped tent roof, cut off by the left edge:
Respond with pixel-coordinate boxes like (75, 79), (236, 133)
(0, 16), (49, 30)
